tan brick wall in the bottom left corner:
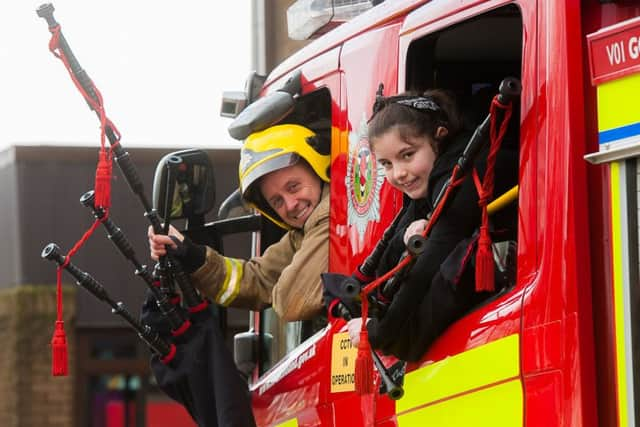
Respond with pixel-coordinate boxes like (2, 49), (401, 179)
(0, 286), (75, 427)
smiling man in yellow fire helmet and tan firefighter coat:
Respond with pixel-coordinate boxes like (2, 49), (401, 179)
(149, 124), (330, 321)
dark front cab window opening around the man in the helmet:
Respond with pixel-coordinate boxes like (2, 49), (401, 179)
(260, 88), (331, 374)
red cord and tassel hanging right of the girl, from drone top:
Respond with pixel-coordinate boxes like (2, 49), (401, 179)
(473, 96), (512, 292)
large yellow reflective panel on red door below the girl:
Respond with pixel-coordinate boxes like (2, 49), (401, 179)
(396, 334), (523, 426)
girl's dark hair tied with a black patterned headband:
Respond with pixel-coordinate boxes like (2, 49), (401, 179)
(369, 89), (462, 153)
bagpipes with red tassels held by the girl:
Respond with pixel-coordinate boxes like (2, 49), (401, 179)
(323, 78), (521, 393)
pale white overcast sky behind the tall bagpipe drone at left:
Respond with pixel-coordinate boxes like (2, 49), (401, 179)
(0, 0), (251, 150)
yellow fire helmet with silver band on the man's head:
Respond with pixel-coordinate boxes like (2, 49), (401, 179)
(238, 124), (330, 229)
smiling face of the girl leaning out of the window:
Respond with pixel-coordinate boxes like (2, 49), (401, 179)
(371, 127), (436, 200)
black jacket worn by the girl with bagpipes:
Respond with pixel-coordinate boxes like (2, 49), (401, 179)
(367, 133), (518, 361)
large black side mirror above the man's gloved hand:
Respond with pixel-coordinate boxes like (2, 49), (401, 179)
(153, 149), (215, 225)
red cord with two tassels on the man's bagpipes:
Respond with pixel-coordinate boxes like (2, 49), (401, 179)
(49, 25), (120, 376)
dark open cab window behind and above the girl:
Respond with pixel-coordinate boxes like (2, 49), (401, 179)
(405, 5), (523, 298)
